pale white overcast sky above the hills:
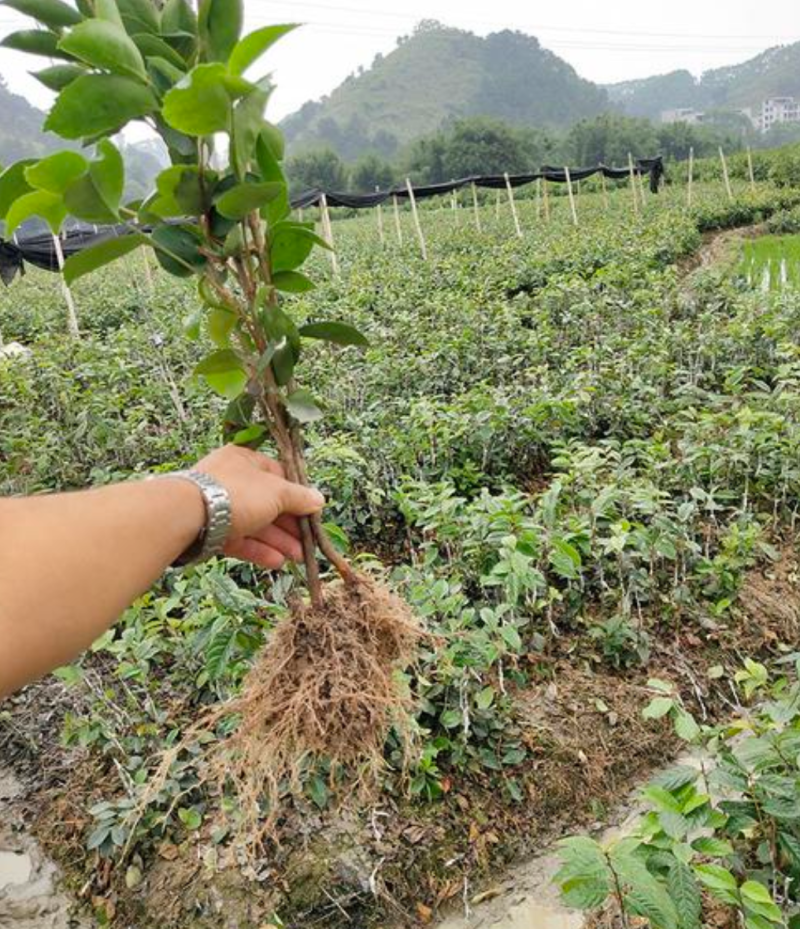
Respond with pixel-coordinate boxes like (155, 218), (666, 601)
(0, 0), (800, 126)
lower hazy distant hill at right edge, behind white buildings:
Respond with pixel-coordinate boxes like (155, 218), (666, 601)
(605, 42), (800, 119)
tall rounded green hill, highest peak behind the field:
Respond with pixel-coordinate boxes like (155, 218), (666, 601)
(281, 21), (608, 159)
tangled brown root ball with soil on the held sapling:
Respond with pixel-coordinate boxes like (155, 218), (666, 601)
(206, 575), (421, 844)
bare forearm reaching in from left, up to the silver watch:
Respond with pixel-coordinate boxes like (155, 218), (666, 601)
(0, 480), (205, 698)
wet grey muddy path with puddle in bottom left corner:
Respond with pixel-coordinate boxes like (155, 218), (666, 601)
(0, 766), (89, 929)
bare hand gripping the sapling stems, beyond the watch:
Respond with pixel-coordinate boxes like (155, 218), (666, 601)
(195, 445), (325, 569)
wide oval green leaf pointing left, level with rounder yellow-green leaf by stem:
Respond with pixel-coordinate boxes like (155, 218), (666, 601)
(44, 74), (158, 139)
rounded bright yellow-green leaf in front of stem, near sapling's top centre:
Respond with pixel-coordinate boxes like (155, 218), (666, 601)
(163, 64), (232, 136)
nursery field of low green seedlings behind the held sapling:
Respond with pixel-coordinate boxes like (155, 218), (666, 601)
(6, 181), (800, 929)
